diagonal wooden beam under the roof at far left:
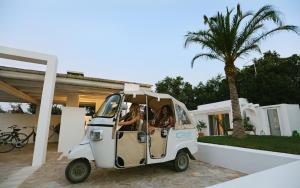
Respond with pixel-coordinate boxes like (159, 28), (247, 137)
(0, 80), (39, 104)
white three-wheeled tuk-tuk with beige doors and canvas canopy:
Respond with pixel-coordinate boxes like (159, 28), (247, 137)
(65, 91), (197, 183)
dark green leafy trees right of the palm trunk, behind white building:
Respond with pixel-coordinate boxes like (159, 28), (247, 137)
(237, 51), (300, 105)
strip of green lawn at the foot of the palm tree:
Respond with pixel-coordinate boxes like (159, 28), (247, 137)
(198, 135), (300, 155)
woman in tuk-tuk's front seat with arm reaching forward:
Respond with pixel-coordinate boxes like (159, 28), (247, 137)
(119, 103), (141, 131)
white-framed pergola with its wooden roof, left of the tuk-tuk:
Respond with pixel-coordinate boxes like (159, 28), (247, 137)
(0, 46), (151, 166)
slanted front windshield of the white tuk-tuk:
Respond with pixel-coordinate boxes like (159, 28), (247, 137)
(96, 94), (121, 118)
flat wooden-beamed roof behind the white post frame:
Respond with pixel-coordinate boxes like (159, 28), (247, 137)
(0, 66), (152, 104)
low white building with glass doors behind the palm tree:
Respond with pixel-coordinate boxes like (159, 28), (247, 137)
(191, 98), (300, 136)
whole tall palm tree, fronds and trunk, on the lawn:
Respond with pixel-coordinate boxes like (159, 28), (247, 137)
(185, 4), (299, 138)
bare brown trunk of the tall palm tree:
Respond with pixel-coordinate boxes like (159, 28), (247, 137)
(225, 63), (246, 138)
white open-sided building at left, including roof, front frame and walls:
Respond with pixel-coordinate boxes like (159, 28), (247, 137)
(0, 46), (151, 166)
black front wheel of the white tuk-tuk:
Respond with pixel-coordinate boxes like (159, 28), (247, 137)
(65, 158), (91, 183)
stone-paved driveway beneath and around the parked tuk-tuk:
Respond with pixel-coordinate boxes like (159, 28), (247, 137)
(0, 145), (244, 188)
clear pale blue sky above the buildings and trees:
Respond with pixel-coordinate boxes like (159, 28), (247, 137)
(0, 0), (300, 86)
